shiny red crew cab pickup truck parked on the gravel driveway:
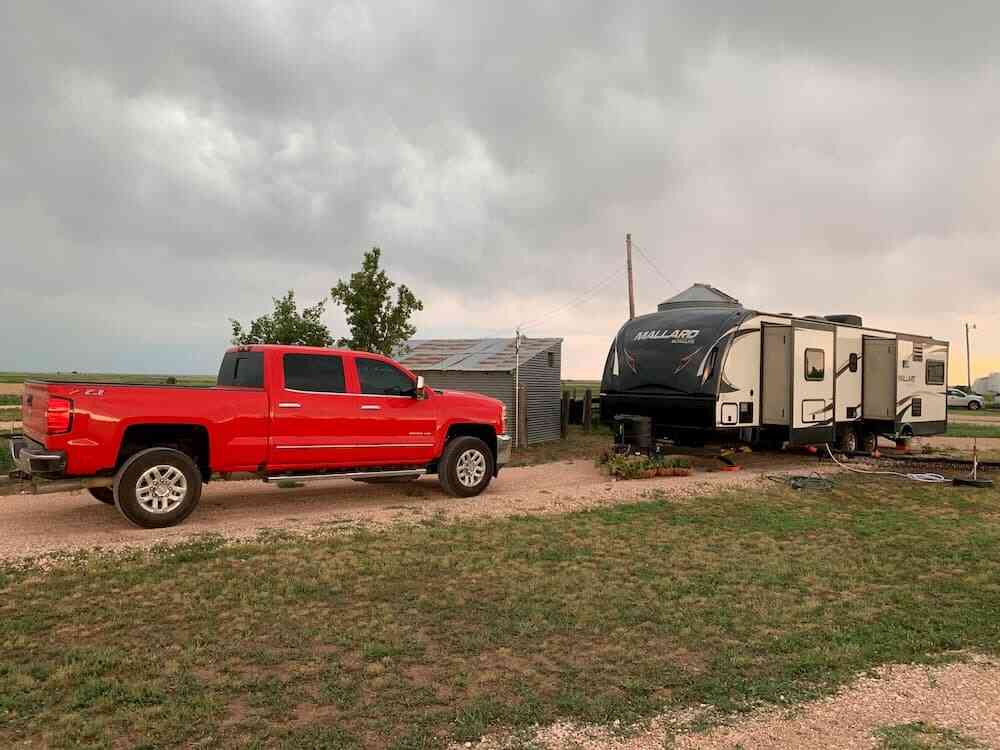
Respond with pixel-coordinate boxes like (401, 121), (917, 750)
(10, 346), (511, 528)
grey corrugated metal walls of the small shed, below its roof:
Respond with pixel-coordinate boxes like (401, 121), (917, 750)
(413, 344), (562, 444)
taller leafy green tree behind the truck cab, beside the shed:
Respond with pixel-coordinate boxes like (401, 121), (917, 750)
(330, 247), (424, 355)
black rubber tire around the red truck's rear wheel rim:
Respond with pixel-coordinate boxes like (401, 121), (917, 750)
(114, 448), (201, 529)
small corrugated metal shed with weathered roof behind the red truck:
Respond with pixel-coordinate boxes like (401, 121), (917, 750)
(395, 338), (562, 445)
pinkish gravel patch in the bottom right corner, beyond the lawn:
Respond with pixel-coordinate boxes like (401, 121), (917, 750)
(468, 655), (1000, 750)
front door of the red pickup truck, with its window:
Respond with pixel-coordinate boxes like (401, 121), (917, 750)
(354, 355), (438, 465)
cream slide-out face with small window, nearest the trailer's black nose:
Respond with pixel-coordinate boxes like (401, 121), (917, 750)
(789, 325), (836, 445)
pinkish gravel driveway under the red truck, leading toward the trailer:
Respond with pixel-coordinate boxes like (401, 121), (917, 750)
(0, 455), (816, 560)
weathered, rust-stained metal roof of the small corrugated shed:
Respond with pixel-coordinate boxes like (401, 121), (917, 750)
(395, 338), (562, 372)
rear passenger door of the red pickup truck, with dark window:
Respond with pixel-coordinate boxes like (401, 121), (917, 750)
(268, 352), (366, 470)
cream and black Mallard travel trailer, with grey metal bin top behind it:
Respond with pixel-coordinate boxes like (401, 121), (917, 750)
(601, 284), (948, 450)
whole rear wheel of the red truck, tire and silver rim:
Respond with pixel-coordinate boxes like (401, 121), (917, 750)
(114, 448), (201, 529)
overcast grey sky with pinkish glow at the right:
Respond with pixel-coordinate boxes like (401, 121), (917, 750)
(0, 0), (1000, 383)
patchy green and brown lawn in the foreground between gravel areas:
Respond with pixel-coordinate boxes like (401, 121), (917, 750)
(0, 476), (1000, 750)
